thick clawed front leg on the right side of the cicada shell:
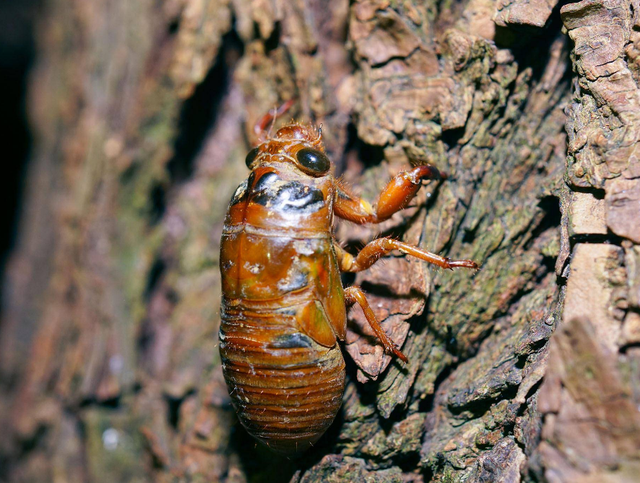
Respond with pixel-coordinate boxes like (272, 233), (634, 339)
(335, 165), (447, 224)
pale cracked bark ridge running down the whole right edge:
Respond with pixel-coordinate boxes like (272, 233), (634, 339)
(539, 0), (640, 482)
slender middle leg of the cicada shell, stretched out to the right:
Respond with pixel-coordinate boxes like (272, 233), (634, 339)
(335, 238), (478, 272)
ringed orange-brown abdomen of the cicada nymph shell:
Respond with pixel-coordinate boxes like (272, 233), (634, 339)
(220, 298), (345, 453)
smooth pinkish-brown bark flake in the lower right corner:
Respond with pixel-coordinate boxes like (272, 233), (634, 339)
(540, 317), (640, 482)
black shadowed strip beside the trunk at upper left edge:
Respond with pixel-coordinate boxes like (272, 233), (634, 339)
(0, 0), (43, 300)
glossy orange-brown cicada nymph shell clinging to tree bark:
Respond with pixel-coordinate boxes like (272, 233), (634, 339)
(219, 103), (478, 454)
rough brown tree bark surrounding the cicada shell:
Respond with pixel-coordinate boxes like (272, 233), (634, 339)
(0, 0), (640, 483)
